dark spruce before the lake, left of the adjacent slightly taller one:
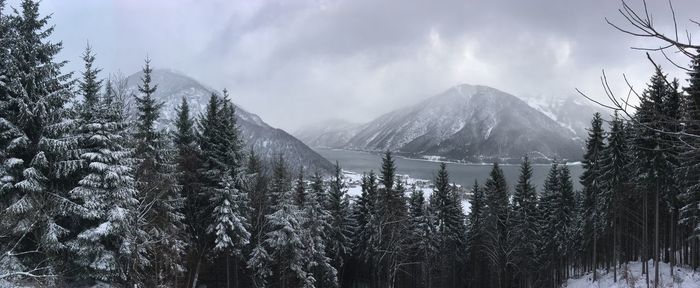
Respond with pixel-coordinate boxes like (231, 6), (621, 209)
(483, 163), (513, 288)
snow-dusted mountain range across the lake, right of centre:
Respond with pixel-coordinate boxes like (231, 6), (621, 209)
(294, 84), (597, 162)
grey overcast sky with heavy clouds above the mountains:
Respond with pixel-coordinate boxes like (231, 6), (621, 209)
(10, 0), (700, 130)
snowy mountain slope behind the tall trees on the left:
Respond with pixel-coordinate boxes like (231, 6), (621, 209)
(126, 69), (333, 172)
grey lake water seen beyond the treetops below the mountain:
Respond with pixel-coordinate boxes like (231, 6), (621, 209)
(314, 148), (583, 191)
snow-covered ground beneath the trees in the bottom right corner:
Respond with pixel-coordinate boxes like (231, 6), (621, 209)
(562, 261), (700, 288)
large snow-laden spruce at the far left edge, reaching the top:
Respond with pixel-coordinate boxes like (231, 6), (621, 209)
(0, 0), (72, 282)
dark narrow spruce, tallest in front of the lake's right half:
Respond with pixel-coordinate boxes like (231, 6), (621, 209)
(512, 156), (539, 287)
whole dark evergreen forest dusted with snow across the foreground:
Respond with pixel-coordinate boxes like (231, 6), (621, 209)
(0, 0), (700, 288)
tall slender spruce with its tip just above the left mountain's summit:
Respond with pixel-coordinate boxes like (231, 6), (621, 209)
(132, 59), (185, 286)
